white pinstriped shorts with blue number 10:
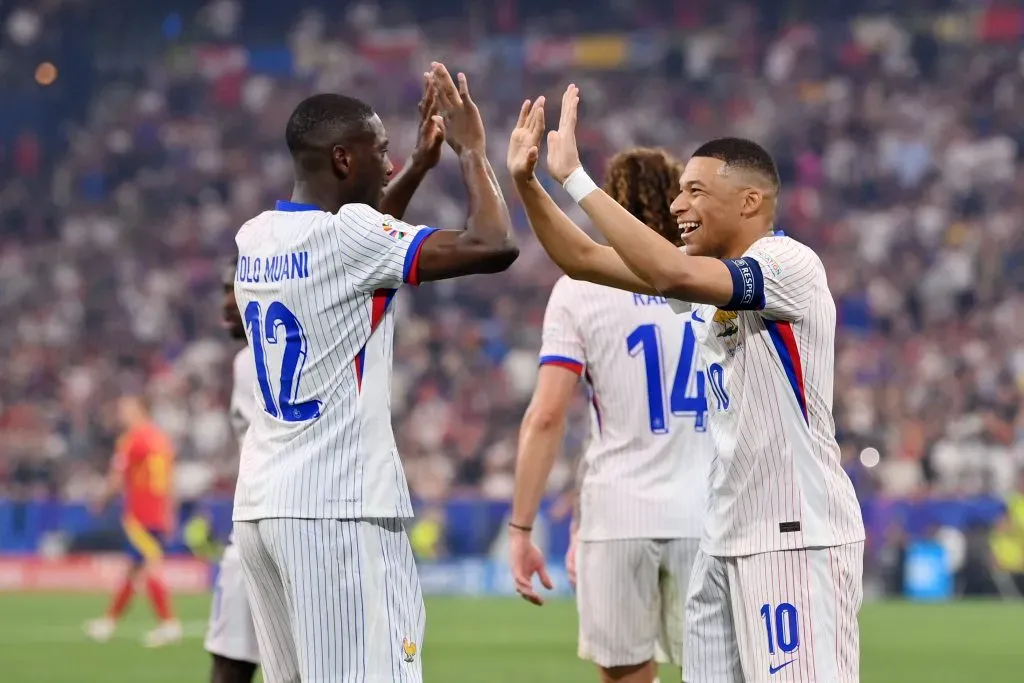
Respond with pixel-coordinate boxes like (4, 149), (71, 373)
(683, 543), (864, 683)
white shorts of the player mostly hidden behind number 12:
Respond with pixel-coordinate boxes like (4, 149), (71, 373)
(204, 545), (259, 664)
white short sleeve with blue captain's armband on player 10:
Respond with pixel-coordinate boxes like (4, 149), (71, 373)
(722, 238), (823, 321)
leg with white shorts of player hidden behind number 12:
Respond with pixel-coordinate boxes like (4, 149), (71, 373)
(204, 545), (259, 683)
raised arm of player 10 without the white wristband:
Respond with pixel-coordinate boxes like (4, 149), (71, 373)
(507, 97), (658, 294)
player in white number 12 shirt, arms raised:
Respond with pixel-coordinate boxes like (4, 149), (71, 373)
(233, 63), (516, 683)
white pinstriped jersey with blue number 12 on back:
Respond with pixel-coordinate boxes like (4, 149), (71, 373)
(234, 202), (433, 521)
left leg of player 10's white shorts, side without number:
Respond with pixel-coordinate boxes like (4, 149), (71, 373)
(683, 550), (745, 683)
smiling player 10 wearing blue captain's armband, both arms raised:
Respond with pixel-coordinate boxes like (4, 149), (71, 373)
(509, 90), (864, 683)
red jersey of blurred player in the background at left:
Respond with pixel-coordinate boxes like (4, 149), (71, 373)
(117, 422), (174, 531)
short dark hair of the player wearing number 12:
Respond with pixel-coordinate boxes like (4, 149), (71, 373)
(285, 93), (374, 154)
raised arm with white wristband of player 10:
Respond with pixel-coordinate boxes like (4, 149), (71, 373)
(548, 85), (733, 306)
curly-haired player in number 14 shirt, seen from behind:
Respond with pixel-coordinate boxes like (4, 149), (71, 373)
(509, 145), (712, 683)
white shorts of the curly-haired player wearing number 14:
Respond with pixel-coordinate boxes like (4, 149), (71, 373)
(577, 539), (700, 668)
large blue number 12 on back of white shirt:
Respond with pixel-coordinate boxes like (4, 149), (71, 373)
(244, 301), (324, 422)
